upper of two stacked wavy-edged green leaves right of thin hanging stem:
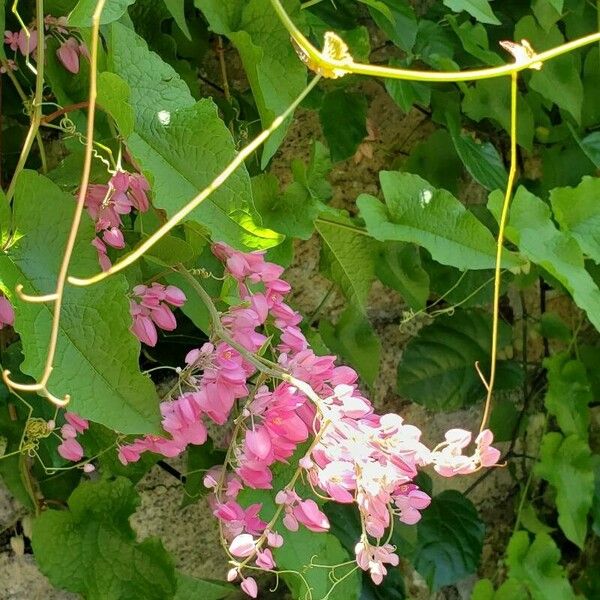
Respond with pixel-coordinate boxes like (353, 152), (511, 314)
(544, 352), (594, 440)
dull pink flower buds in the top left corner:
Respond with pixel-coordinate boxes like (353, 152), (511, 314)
(4, 15), (90, 74)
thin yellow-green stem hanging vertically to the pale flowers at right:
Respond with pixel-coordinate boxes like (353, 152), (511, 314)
(479, 71), (519, 432)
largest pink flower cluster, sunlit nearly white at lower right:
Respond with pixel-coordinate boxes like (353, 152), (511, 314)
(119, 243), (500, 597)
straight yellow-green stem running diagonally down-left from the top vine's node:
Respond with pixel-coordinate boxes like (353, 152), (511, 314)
(68, 75), (321, 286)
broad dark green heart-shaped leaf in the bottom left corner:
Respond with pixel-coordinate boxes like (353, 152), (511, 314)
(32, 478), (176, 600)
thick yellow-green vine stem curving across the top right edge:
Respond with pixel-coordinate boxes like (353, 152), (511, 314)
(271, 0), (600, 83)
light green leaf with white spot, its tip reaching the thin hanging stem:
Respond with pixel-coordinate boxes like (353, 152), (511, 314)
(357, 171), (518, 269)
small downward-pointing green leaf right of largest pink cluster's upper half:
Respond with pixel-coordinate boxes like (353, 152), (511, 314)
(319, 307), (381, 387)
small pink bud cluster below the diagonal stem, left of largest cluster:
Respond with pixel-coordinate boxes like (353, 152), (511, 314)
(129, 282), (186, 346)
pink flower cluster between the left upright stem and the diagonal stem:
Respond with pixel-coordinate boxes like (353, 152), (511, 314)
(85, 170), (150, 271)
